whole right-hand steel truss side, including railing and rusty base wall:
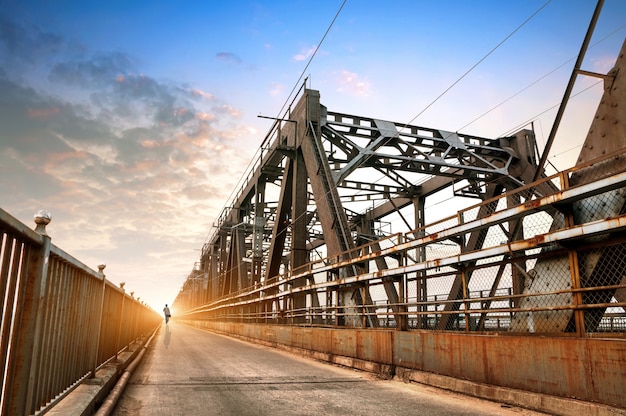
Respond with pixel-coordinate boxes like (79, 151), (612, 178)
(173, 38), (626, 414)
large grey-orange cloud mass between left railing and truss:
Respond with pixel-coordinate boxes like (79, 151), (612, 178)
(0, 15), (255, 308)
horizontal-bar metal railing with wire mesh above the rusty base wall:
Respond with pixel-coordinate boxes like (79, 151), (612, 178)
(176, 153), (626, 337)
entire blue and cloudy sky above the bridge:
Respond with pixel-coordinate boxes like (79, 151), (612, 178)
(0, 0), (626, 311)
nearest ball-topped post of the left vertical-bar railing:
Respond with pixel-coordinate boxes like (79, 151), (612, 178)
(2, 211), (51, 415)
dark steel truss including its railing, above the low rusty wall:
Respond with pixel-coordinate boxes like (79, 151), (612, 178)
(175, 39), (626, 334)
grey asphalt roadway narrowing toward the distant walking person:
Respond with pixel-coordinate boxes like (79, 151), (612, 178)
(113, 321), (541, 416)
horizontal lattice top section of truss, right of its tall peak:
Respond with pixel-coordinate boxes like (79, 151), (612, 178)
(322, 112), (522, 188)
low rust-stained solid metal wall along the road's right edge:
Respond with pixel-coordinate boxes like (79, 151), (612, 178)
(188, 321), (626, 408)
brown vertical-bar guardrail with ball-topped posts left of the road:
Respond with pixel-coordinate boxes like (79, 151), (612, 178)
(0, 209), (161, 415)
